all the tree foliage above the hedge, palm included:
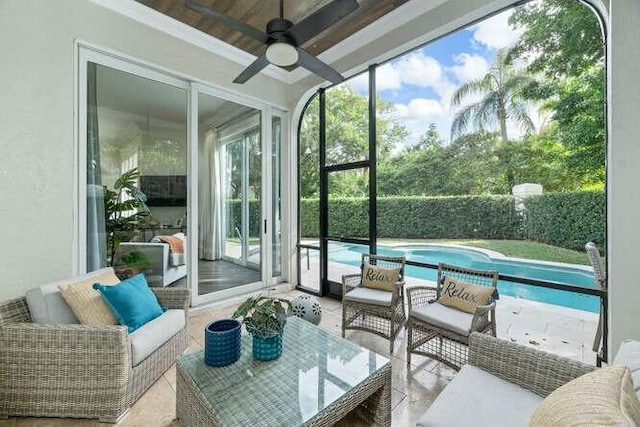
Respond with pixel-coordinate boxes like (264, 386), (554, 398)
(300, 0), (606, 201)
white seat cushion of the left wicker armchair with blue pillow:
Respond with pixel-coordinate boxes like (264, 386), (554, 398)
(129, 310), (186, 366)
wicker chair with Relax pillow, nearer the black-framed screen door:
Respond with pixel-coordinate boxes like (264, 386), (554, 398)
(342, 254), (406, 354)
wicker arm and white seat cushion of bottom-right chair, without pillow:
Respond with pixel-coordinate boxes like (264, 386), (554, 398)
(416, 333), (596, 427)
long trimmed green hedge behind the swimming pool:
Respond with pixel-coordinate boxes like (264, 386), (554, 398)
(242, 191), (606, 251)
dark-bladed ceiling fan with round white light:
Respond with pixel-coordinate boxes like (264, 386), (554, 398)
(187, 0), (358, 83)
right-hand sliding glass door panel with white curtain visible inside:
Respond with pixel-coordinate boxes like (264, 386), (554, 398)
(197, 88), (282, 301)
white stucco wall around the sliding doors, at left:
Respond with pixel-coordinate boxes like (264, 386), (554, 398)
(0, 0), (289, 300)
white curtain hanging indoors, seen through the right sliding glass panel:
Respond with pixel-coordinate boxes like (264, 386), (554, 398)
(198, 129), (222, 261)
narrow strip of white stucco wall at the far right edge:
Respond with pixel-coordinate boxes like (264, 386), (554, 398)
(607, 0), (640, 355)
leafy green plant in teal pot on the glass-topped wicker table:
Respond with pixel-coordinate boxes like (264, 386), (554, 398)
(233, 295), (291, 360)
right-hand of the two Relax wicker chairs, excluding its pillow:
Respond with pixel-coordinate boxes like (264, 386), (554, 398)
(407, 263), (498, 369)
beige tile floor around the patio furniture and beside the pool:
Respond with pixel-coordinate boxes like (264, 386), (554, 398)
(0, 290), (598, 427)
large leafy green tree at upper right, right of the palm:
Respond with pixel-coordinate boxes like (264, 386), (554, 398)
(509, 0), (606, 188)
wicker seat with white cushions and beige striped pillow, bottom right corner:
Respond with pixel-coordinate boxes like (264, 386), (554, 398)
(417, 333), (640, 427)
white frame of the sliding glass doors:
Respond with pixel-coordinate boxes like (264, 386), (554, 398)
(74, 40), (290, 305)
